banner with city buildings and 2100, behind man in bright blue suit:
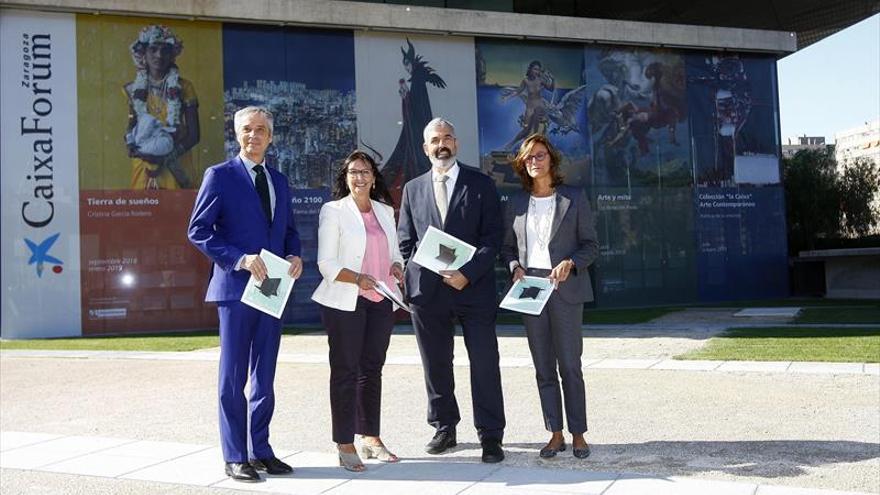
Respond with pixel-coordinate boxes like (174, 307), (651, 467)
(223, 24), (357, 323)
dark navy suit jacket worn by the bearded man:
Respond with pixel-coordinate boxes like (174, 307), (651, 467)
(397, 164), (501, 310)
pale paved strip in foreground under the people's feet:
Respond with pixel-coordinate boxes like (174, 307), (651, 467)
(0, 432), (872, 495)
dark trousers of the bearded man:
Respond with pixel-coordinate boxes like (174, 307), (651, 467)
(411, 286), (505, 440)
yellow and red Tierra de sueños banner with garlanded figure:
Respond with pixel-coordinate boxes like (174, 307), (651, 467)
(76, 16), (224, 334)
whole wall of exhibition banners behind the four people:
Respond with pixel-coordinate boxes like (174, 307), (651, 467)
(0, 9), (788, 338)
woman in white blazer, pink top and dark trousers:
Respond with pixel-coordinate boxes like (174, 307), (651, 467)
(312, 150), (403, 472)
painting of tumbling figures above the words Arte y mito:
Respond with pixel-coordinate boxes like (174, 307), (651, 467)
(584, 46), (693, 187)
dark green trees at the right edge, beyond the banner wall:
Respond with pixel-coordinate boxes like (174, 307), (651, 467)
(783, 149), (880, 255)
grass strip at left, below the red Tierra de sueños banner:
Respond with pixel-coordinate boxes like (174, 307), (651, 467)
(0, 327), (320, 352)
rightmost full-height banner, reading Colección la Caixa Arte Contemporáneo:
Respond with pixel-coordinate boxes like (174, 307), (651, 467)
(686, 53), (788, 301)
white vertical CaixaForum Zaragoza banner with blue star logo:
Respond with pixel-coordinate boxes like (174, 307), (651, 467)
(0, 10), (80, 338)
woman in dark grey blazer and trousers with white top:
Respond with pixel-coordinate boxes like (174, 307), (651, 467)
(501, 134), (599, 458)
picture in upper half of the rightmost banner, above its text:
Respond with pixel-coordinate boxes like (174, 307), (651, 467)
(685, 53), (780, 187)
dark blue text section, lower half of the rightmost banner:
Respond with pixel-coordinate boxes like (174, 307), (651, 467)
(695, 186), (788, 301)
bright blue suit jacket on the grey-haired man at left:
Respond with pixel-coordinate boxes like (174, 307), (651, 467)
(188, 157), (300, 302)
